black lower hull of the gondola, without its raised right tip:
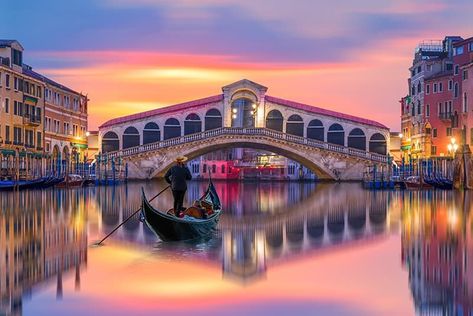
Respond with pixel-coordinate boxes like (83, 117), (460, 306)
(142, 192), (221, 241)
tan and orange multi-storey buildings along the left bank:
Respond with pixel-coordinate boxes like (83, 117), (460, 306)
(0, 40), (88, 177)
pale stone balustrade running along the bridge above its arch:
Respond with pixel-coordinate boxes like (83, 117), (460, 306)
(103, 127), (388, 162)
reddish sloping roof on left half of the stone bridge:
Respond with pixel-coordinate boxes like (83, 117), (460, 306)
(99, 94), (223, 129)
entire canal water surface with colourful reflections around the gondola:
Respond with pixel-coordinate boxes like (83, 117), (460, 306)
(0, 181), (473, 315)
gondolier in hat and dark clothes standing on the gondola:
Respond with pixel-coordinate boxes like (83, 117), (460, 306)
(164, 157), (192, 216)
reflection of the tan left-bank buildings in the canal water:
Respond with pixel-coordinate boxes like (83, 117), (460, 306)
(0, 191), (87, 315)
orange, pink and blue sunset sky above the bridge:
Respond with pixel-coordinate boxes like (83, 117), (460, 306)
(0, 0), (473, 130)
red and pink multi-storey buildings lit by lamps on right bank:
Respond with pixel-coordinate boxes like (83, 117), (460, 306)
(400, 36), (473, 159)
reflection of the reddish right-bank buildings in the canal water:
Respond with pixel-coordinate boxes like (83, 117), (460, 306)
(402, 192), (473, 315)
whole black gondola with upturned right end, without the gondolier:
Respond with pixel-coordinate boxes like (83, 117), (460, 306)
(141, 182), (222, 241)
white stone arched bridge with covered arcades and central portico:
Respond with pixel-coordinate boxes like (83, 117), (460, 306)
(99, 80), (389, 180)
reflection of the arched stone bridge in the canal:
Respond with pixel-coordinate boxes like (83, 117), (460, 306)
(94, 182), (397, 280)
